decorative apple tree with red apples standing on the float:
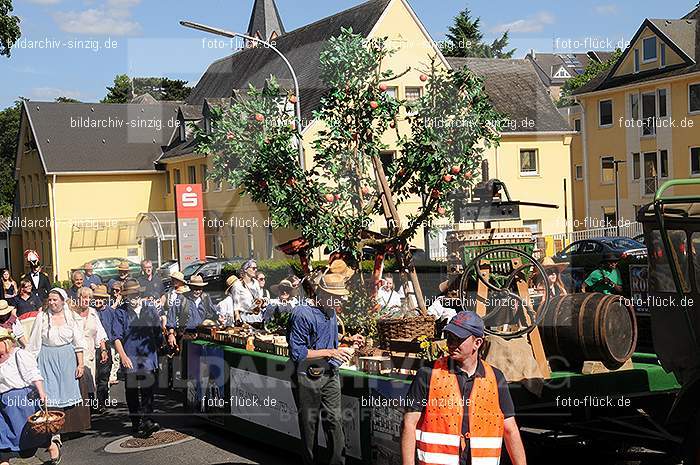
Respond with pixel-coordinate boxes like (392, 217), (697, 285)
(197, 30), (499, 333)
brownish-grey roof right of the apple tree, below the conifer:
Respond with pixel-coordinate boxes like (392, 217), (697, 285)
(447, 58), (570, 134)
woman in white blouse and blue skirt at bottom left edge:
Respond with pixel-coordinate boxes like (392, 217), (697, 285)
(0, 328), (60, 465)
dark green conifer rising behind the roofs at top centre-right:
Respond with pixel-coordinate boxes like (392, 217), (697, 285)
(442, 8), (515, 58)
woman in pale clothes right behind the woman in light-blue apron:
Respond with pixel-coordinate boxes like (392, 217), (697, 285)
(75, 287), (109, 397)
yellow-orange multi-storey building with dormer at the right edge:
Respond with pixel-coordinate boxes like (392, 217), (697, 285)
(574, 7), (700, 228)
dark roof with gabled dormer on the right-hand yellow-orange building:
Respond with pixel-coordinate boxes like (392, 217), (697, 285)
(572, 15), (700, 95)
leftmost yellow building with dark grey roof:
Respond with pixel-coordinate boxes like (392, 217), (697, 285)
(13, 101), (177, 280)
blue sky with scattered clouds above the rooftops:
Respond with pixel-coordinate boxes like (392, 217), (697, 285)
(0, 0), (697, 108)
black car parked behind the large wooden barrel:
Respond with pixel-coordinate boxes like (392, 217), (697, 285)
(552, 236), (647, 291)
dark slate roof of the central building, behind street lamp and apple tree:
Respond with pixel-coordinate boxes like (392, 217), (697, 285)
(187, 0), (390, 121)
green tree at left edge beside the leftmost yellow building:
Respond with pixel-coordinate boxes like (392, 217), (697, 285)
(0, 100), (21, 216)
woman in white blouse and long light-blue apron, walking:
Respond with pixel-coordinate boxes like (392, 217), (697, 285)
(28, 288), (90, 436)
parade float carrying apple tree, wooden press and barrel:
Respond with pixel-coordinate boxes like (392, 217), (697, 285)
(181, 31), (679, 464)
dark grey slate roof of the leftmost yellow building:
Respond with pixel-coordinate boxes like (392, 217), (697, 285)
(24, 101), (178, 173)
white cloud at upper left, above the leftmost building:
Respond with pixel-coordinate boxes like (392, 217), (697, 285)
(54, 8), (141, 36)
